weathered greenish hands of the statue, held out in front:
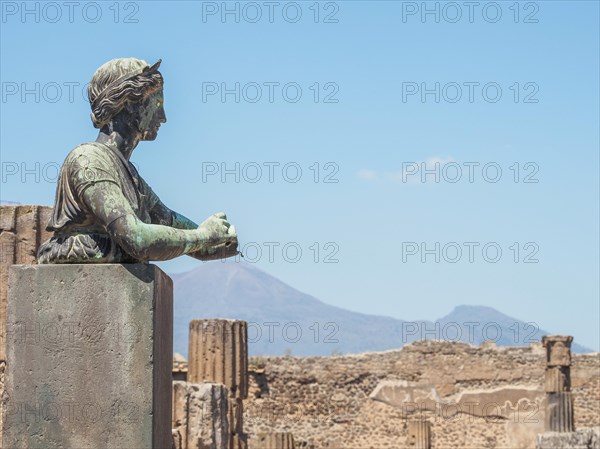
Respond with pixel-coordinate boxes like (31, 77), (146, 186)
(195, 212), (238, 260)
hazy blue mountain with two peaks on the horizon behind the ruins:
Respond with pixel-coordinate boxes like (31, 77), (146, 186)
(171, 261), (590, 356)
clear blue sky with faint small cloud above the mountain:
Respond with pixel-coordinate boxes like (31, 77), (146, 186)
(0, 1), (600, 349)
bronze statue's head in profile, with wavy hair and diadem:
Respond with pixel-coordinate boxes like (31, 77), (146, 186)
(88, 58), (167, 140)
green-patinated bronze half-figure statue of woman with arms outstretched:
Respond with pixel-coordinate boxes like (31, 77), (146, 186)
(37, 58), (238, 263)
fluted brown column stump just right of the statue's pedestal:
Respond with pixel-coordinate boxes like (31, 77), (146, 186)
(187, 319), (248, 449)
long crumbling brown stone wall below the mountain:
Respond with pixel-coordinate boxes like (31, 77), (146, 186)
(244, 341), (600, 449)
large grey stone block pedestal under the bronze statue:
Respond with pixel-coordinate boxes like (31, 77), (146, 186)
(3, 264), (173, 449)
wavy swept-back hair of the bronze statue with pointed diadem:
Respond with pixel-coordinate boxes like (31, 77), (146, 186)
(88, 58), (163, 128)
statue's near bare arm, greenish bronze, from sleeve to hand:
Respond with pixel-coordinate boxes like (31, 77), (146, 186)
(83, 181), (237, 261)
